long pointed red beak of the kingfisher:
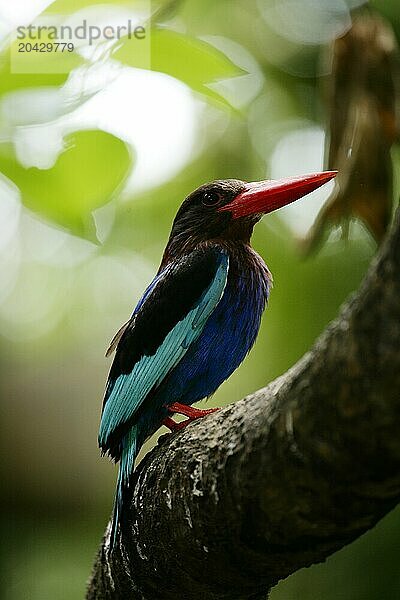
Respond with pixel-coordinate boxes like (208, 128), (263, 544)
(219, 171), (337, 219)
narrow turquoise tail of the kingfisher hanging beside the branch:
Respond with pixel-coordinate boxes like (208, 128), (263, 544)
(110, 425), (140, 551)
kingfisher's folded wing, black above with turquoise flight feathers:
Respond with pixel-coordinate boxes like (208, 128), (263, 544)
(99, 250), (229, 457)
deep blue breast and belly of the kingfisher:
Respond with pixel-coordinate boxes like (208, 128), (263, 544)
(153, 249), (272, 404)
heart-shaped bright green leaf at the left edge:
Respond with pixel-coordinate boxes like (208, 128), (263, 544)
(0, 130), (131, 240)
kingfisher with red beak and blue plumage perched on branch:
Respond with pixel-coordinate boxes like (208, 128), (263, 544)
(99, 171), (336, 550)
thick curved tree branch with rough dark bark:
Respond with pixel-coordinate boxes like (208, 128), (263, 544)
(87, 213), (400, 600)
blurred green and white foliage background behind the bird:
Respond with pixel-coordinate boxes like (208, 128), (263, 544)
(0, 0), (400, 600)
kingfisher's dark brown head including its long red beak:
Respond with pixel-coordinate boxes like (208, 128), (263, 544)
(164, 171), (336, 260)
